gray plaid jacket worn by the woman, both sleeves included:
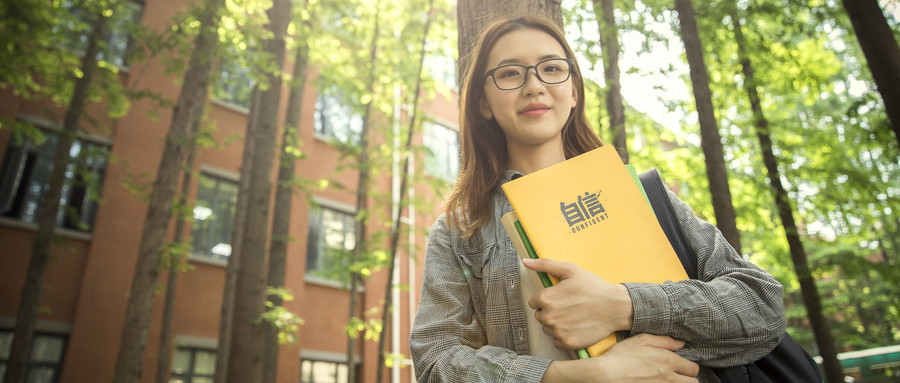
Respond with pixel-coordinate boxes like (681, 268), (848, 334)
(409, 171), (785, 383)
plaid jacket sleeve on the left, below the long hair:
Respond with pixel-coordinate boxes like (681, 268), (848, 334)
(409, 216), (550, 383)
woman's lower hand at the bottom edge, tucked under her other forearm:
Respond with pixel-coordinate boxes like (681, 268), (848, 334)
(541, 334), (700, 383)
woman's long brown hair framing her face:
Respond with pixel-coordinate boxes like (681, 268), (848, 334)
(444, 16), (603, 236)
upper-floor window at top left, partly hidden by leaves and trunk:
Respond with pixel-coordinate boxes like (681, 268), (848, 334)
(59, 0), (144, 66)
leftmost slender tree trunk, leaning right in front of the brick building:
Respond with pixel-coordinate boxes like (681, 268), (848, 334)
(3, 9), (109, 383)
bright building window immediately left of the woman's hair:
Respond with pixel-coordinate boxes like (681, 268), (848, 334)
(424, 122), (459, 182)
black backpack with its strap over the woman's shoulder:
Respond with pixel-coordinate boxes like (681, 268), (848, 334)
(639, 169), (822, 383)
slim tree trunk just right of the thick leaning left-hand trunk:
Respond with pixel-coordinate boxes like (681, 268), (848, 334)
(156, 143), (200, 383)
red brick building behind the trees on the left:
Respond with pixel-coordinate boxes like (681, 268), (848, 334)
(0, 0), (457, 383)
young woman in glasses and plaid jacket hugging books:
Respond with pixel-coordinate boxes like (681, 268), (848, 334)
(409, 17), (784, 382)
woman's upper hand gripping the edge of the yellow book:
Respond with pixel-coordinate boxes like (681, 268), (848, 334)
(523, 258), (634, 350)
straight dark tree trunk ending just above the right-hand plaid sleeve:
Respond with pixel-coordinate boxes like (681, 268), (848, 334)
(675, 0), (742, 254)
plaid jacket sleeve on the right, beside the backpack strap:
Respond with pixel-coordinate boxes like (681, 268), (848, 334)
(625, 191), (785, 367)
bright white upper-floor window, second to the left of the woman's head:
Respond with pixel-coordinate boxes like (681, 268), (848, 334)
(314, 88), (363, 145)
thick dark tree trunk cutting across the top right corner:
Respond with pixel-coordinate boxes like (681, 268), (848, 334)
(842, 0), (900, 145)
